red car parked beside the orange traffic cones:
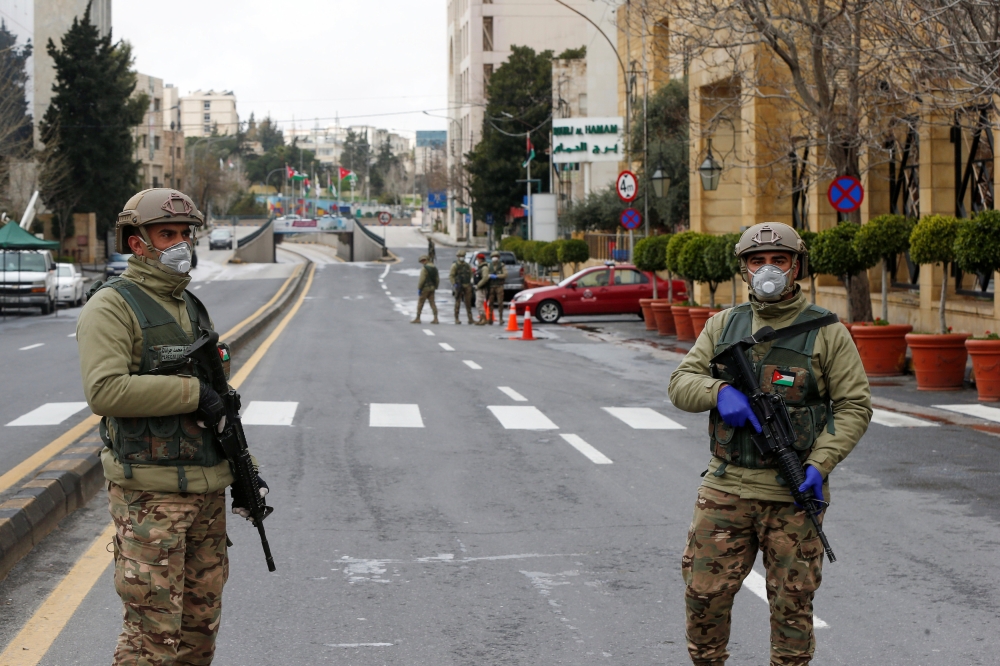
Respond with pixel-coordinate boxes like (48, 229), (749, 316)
(514, 264), (687, 324)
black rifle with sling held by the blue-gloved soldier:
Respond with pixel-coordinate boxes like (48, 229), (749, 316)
(712, 315), (839, 562)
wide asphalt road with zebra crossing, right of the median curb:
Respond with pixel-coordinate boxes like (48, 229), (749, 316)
(0, 248), (1000, 666)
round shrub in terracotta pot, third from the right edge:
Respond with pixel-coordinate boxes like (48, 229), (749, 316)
(851, 215), (913, 377)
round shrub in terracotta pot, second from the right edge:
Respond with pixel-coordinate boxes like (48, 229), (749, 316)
(906, 215), (969, 391)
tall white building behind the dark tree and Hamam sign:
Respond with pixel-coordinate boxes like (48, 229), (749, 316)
(447, 0), (619, 239)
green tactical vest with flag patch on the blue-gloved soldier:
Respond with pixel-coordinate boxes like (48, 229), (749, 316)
(708, 303), (834, 466)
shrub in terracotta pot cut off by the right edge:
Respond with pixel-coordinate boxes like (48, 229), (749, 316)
(954, 210), (1000, 402)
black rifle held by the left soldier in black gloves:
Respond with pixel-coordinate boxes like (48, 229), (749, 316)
(186, 331), (274, 571)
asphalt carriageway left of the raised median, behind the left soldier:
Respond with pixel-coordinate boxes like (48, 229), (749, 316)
(0, 239), (301, 488)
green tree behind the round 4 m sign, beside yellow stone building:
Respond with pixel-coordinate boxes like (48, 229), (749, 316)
(631, 79), (691, 231)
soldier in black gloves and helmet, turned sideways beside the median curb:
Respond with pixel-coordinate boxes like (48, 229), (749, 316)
(76, 188), (267, 665)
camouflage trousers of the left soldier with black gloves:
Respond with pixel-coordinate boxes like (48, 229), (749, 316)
(108, 482), (229, 666)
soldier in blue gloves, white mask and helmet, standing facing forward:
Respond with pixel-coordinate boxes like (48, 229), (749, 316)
(669, 223), (872, 666)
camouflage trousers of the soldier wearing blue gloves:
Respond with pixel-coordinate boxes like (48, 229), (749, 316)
(681, 486), (823, 666)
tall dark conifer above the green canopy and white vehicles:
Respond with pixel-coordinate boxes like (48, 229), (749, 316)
(40, 5), (149, 235)
